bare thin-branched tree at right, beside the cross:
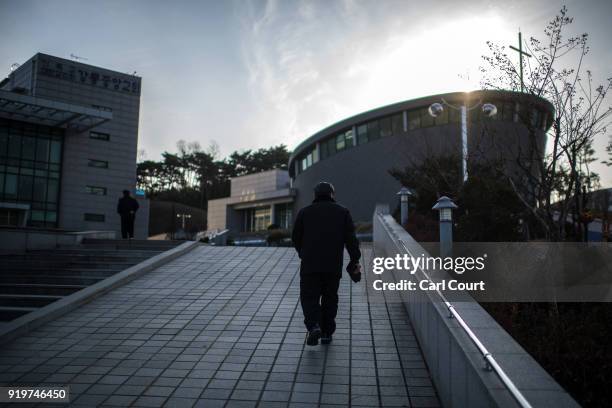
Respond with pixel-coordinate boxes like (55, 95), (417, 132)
(481, 6), (612, 241)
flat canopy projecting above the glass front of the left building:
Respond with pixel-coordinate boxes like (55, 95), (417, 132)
(0, 90), (113, 133)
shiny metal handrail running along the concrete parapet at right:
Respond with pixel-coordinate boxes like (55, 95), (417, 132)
(376, 213), (532, 408)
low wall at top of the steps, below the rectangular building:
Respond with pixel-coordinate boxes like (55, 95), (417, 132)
(0, 227), (116, 254)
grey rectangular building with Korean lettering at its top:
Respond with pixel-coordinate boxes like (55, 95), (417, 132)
(0, 53), (148, 238)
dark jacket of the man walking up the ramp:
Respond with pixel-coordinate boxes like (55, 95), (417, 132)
(292, 197), (361, 277)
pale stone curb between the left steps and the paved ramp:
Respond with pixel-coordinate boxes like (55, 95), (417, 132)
(0, 241), (199, 344)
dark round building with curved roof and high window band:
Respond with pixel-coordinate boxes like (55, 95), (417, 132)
(289, 91), (553, 221)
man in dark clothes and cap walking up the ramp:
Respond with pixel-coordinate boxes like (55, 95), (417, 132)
(292, 182), (361, 346)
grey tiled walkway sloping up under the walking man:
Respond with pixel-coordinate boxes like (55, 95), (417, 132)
(0, 246), (438, 408)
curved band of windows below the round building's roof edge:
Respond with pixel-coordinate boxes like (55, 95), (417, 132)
(297, 101), (547, 173)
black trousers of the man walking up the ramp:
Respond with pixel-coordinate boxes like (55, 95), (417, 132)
(300, 274), (341, 334)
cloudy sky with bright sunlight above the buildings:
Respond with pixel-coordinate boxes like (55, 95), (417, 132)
(0, 0), (612, 185)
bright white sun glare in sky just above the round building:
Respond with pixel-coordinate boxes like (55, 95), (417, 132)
(361, 14), (515, 107)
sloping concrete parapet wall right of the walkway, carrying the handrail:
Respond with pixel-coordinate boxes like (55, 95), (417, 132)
(373, 206), (579, 407)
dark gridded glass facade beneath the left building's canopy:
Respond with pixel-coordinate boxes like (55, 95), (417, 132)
(0, 119), (63, 227)
